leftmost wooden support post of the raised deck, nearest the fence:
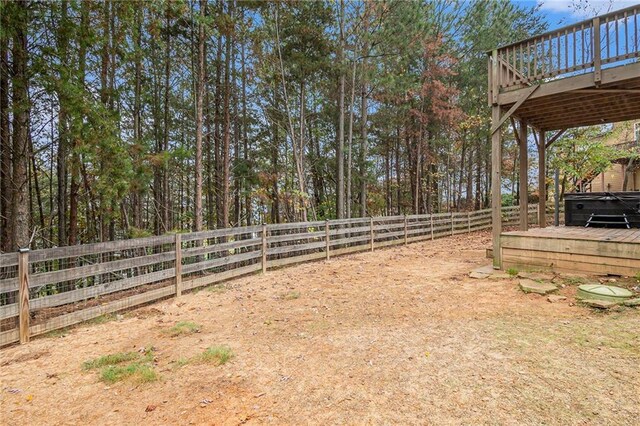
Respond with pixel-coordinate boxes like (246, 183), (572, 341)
(491, 104), (502, 268)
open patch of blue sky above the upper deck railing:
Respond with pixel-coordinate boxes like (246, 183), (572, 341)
(511, 0), (639, 30)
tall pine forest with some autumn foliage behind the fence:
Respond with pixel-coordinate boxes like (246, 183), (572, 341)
(0, 0), (546, 251)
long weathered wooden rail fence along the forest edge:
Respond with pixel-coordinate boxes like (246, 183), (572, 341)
(0, 205), (537, 346)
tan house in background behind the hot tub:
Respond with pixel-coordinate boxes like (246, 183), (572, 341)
(584, 121), (640, 192)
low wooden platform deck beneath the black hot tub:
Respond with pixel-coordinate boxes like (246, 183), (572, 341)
(500, 226), (640, 276)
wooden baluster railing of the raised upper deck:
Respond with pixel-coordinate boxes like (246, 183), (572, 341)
(489, 5), (640, 89)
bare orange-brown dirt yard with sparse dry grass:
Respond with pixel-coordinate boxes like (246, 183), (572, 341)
(0, 233), (640, 425)
